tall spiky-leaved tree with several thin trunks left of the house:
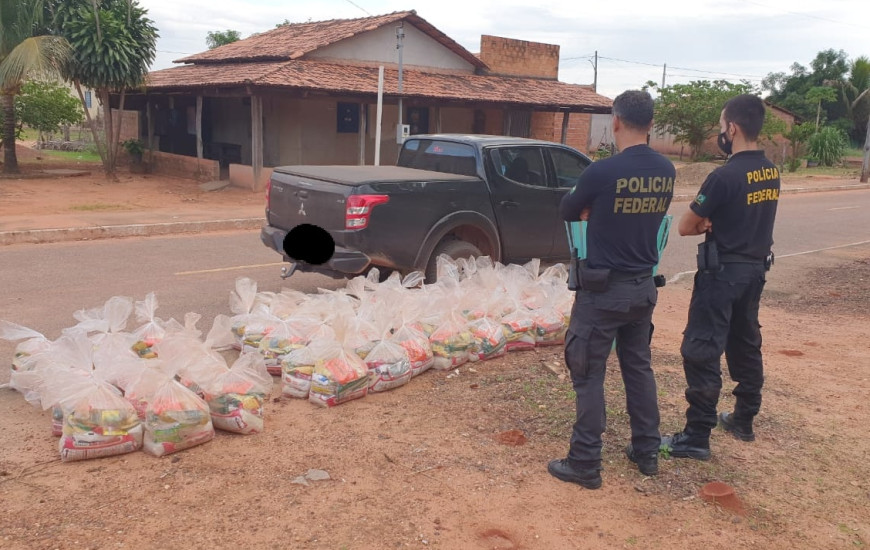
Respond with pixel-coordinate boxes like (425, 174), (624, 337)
(55, 0), (158, 175)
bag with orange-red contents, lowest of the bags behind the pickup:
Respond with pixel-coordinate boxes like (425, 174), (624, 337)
(308, 342), (369, 407)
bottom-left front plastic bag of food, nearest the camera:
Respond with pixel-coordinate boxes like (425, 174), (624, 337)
(58, 381), (143, 462)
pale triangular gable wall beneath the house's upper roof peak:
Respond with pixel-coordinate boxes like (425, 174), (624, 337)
(306, 23), (474, 72)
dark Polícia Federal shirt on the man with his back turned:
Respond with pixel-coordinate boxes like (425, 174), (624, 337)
(560, 145), (676, 271)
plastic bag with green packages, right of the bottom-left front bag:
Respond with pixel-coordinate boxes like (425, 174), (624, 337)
(142, 378), (214, 456)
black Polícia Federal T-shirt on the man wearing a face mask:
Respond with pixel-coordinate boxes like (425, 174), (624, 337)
(689, 150), (780, 260)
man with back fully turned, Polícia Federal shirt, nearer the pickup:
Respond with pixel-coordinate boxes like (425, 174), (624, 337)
(547, 90), (675, 489)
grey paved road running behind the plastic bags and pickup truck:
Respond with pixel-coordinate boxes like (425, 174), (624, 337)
(0, 190), (870, 383)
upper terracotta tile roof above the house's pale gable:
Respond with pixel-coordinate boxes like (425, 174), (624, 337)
(176, 10), (486, 67)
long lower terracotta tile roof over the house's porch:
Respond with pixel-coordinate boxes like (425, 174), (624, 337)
(148, 60), (612, 112)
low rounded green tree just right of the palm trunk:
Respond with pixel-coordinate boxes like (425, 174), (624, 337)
(16, 80), (84, 141)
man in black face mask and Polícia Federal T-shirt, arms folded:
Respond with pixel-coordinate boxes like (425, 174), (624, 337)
(663, 94), (780, 460)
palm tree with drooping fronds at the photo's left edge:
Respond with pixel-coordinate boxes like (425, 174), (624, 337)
(0, 0), (69, 174)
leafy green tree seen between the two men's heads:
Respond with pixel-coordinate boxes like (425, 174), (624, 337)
(648, 80), (752, 159)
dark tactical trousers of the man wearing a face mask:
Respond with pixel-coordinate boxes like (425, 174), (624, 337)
(680, 263), (765, 437)
